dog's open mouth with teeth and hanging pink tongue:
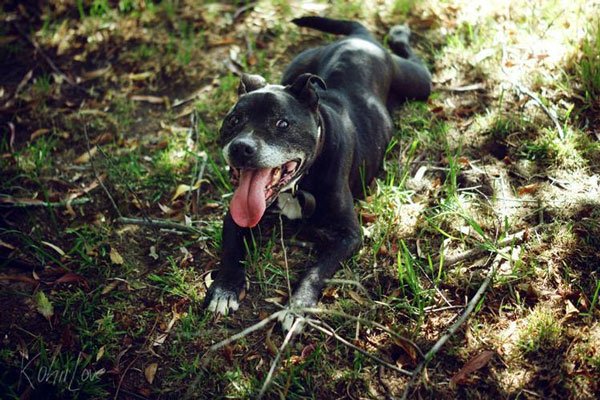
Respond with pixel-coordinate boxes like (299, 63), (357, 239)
(229, 160), (301, 228)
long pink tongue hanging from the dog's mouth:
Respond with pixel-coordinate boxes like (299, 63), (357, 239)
(229, 168), (272, 228)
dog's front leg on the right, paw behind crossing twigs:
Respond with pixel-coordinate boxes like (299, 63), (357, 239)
(280, 200), (361, 331)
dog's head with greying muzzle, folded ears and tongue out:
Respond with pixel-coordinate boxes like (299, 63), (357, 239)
(220, 74), (325, 227)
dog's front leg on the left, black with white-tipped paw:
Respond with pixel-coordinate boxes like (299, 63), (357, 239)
(204, 212), (251, 315)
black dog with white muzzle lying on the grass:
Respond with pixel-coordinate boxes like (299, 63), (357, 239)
(205, 17), (431, 330)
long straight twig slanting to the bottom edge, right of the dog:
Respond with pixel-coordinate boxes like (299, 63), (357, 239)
(402, 254), (502, 399)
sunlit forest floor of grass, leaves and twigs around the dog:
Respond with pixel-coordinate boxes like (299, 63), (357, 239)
(0, 0), (600, 399)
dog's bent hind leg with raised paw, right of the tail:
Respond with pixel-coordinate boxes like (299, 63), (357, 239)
(387, 25), (431, 107)
